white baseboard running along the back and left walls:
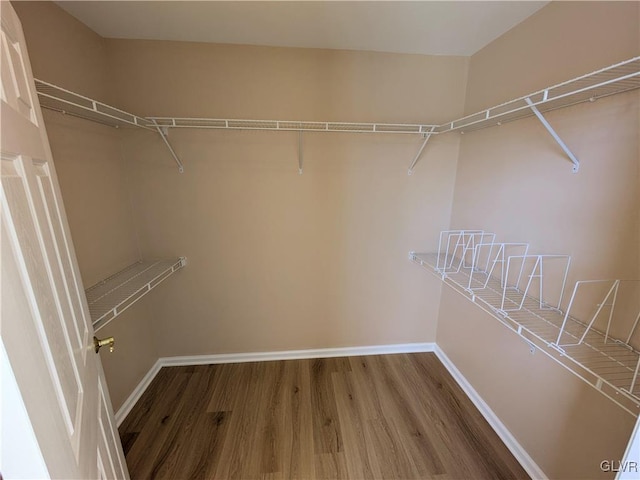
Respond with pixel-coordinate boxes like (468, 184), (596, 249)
(115, 343), (436, 427)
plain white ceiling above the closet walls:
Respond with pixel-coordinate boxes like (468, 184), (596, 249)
(56, 1), (548, 56)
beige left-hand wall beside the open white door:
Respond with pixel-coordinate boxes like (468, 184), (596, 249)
(14, 2), (157, 409)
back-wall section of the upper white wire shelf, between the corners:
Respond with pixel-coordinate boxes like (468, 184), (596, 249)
(148, 117), (435, 134)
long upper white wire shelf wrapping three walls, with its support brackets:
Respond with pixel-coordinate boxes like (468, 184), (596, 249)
(36, 57), (640, 175)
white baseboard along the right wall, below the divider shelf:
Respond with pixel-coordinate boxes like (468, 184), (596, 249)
(434, 345), (548, 480)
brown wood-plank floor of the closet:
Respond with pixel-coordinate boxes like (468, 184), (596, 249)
(120, 353), (528, 480)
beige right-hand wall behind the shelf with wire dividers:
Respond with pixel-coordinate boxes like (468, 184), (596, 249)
(437, 2), (640, 478)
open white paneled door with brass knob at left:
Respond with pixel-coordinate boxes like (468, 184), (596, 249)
(0, 1), (128, 479)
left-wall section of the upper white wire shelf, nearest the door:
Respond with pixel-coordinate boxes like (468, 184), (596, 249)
(35, 79), (156, 131)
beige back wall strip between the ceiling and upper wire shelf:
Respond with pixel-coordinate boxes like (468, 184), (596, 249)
(107, 39), (468, 123)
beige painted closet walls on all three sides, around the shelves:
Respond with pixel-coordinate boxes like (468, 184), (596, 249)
(16, 2), (640, 472)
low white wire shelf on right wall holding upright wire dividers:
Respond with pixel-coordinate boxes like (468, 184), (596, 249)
(409, 231), (640, 416)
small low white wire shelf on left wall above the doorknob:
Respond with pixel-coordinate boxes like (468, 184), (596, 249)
(85, 257), (186, 331)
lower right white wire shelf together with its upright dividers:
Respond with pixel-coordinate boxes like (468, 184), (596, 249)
(409, 230), (640, 417)
